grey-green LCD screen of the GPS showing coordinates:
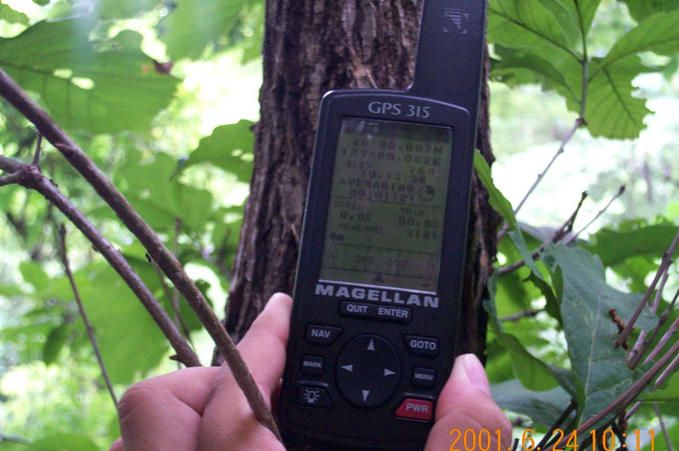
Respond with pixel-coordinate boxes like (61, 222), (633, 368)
(320, 118), (453, 291)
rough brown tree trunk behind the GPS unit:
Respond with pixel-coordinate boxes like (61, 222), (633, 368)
(225, 0), (497, 355)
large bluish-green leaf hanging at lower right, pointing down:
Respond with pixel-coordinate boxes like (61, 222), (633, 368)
(545, 245), (655, 422)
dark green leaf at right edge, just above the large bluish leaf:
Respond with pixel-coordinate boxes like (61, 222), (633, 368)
(586, 223), (678, 266)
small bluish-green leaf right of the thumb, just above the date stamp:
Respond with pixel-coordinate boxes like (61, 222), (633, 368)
(490, 380), (571, 428)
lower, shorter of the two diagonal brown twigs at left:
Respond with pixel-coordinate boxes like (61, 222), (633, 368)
(0, 155), (200, 366)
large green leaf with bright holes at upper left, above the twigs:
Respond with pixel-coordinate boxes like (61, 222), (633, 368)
(0, 19), (178, 133)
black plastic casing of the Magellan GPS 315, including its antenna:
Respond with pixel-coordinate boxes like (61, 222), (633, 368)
(278, 0), (487, 450)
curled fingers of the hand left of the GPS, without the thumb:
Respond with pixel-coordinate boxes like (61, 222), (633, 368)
(111, 294), (292, 451)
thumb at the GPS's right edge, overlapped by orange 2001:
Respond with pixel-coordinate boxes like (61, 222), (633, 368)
(425, 354), (512, 451)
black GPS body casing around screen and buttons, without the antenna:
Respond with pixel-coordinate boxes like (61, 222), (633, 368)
(280, 90), (473, 449)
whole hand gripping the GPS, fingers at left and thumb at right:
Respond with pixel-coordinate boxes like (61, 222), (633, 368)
(111, 294), (511, 451)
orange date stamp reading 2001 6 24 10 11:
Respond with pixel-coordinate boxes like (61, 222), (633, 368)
(449, 428), (655, 451)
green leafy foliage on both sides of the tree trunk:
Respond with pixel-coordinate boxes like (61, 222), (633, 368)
(0, 0), (679, 449)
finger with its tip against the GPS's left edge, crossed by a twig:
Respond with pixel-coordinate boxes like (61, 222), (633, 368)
(199, 293), (292, 449)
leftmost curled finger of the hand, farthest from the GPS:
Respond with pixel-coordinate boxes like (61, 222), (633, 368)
(117, 367), (219, 451)
